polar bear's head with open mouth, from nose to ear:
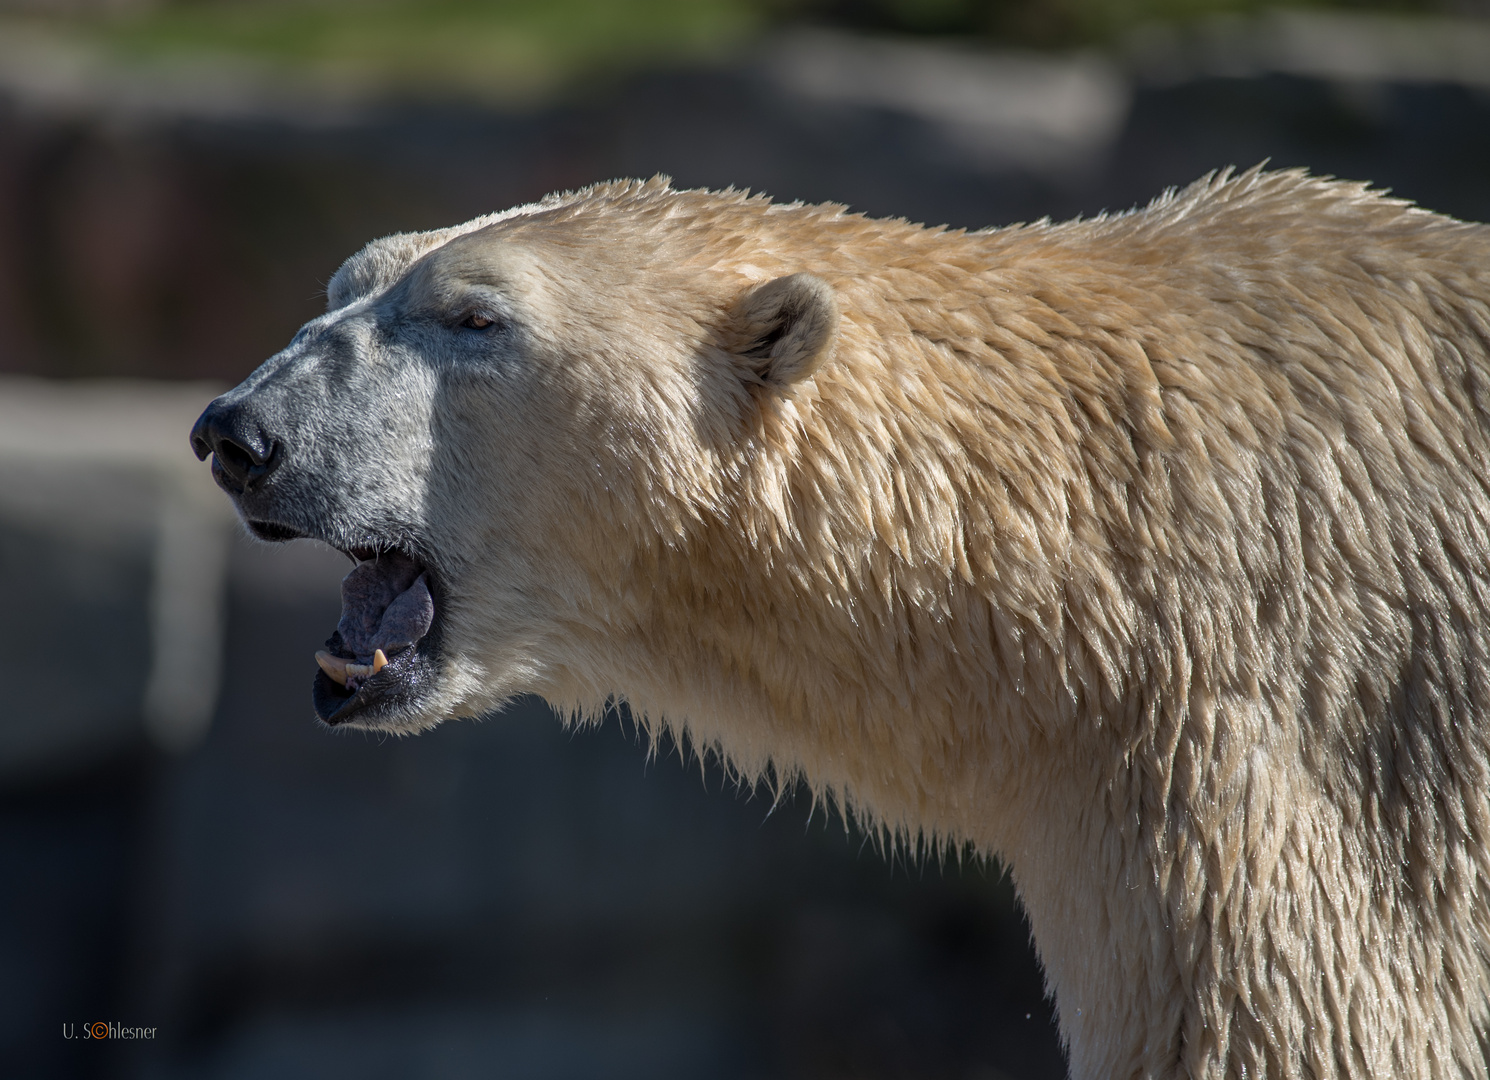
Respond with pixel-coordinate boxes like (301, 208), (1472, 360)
(192, 180), (839, 731)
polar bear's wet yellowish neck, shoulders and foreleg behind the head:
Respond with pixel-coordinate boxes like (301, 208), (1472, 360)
(533, 174), (1490, 1079)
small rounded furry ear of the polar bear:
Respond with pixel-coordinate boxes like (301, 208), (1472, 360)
(726, 274), (837, 386)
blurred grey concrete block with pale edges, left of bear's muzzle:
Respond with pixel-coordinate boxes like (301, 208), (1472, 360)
(0, 377), (234, 776)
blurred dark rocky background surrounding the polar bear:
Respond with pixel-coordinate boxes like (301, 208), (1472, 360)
(0, 0), (1490, 1080)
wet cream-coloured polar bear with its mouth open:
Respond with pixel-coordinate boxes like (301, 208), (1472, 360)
(192, 170), (1490, 1080)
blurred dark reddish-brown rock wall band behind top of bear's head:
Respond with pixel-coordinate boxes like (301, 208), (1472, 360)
(0, 61), (1490, 380)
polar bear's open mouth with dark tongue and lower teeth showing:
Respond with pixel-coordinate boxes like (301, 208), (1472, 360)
(249, 521), (440, 725)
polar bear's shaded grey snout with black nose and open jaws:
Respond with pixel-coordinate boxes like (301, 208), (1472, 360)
(191, 336), (444, 730)
